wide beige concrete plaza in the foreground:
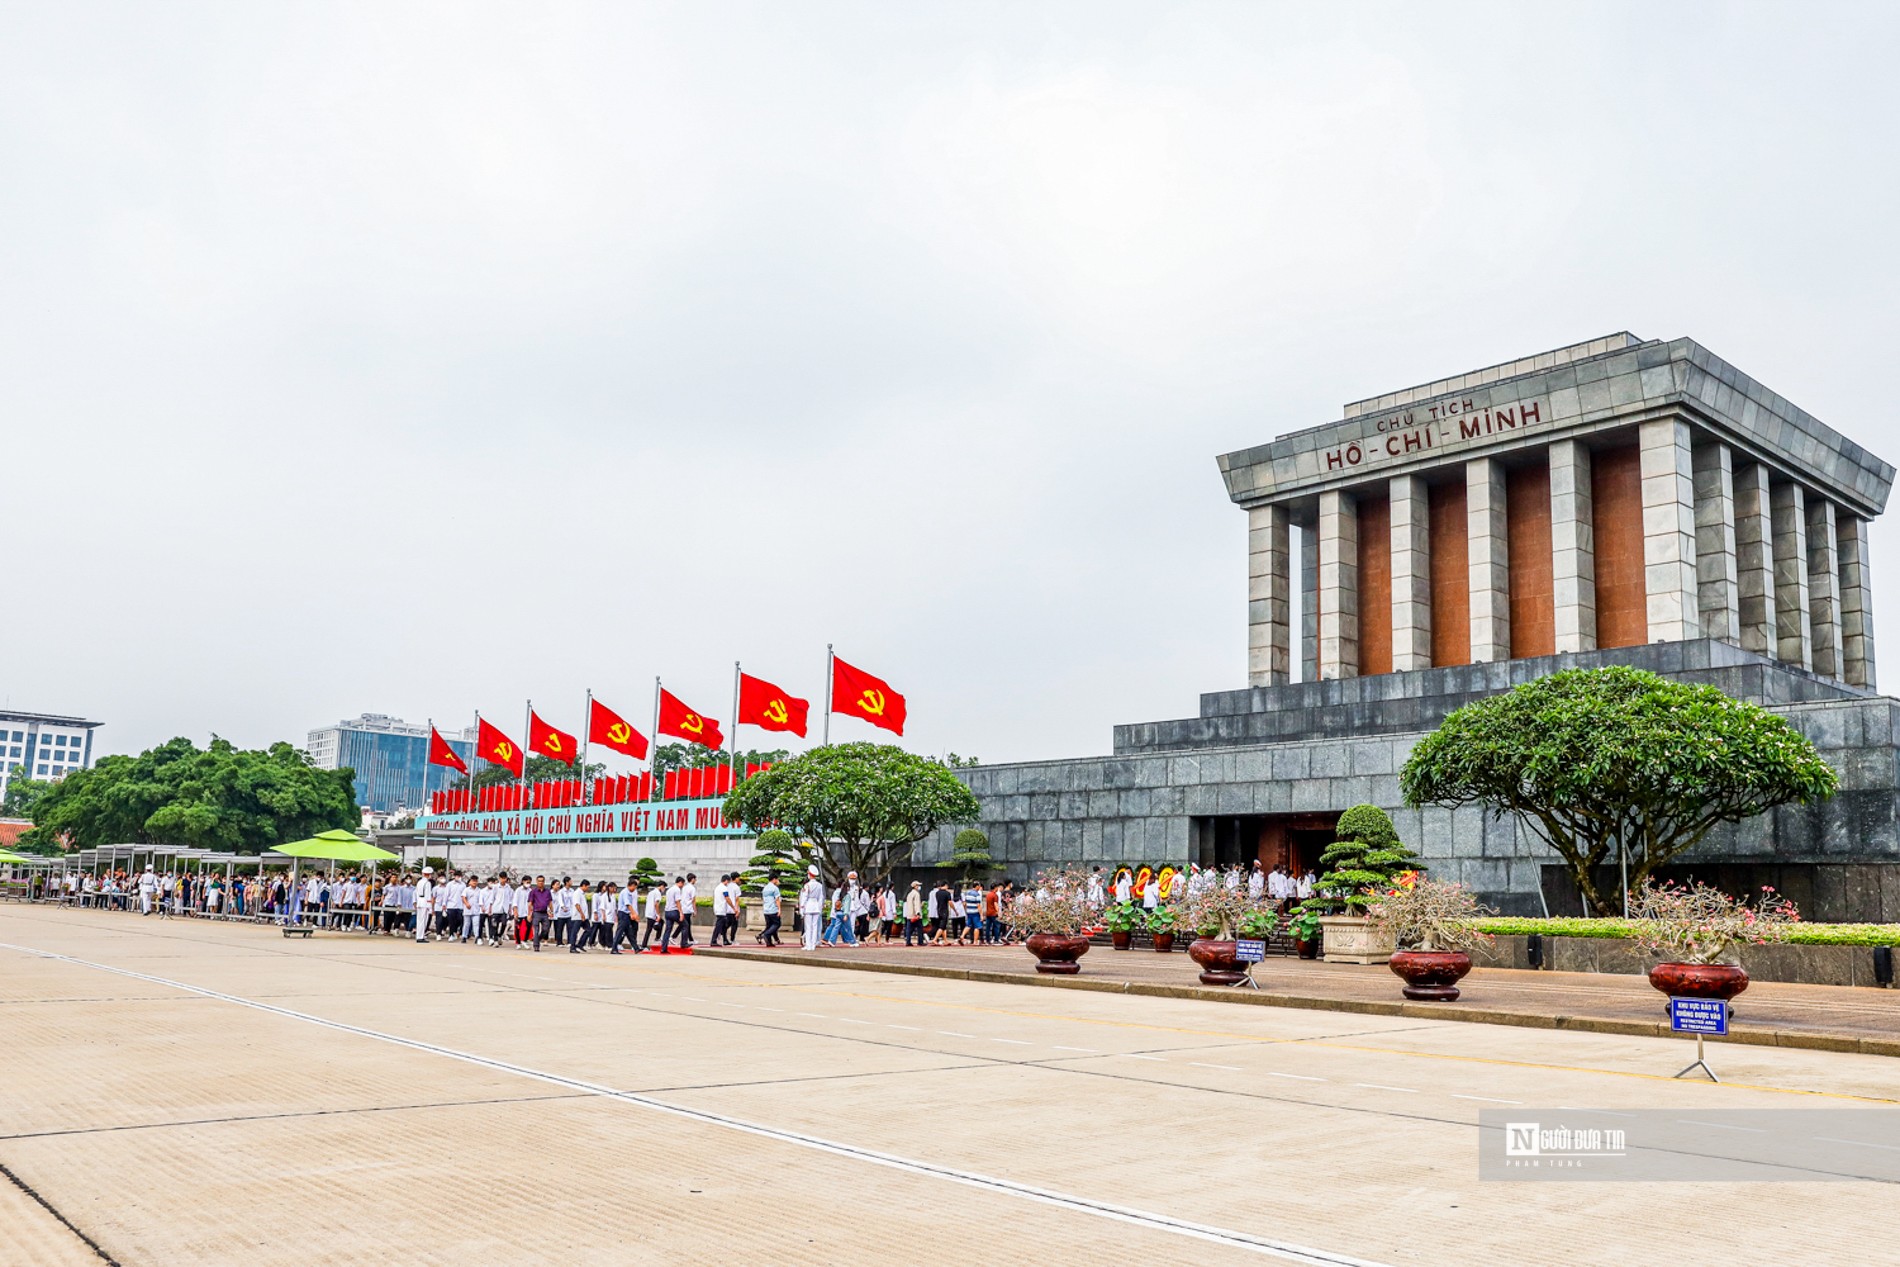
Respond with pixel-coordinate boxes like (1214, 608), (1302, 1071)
(0, 904), (1900, 1265)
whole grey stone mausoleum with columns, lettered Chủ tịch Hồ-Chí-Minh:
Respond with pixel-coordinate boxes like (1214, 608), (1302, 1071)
(918, 334), (1900, 921)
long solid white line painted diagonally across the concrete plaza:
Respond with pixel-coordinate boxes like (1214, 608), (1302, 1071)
(0, 942), (1383, 1267)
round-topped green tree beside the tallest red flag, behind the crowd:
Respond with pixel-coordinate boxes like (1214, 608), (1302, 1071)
(726, 743), (979, 883)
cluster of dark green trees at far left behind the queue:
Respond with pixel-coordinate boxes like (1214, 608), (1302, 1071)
(29, 739), (361, 853)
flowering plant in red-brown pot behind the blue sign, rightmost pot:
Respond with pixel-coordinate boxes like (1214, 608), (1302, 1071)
(1630, 879), (1801, 999)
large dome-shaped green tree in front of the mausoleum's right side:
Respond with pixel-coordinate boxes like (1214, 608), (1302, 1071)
(1398, 665), (1839, 916)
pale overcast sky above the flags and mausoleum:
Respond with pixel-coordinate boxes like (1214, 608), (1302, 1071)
(0, 0), (1900, 760)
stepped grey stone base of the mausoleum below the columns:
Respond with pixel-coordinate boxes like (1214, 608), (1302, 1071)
(918, 640), (1900, 919)
